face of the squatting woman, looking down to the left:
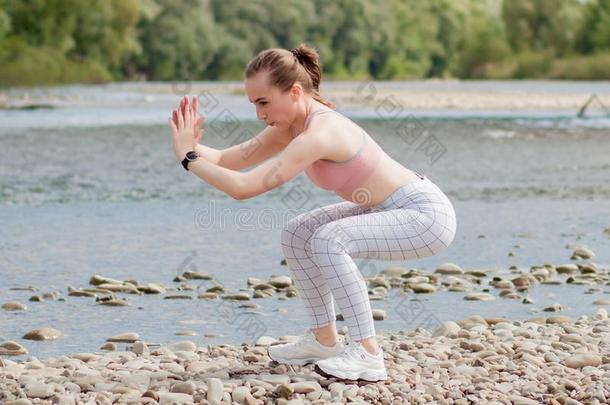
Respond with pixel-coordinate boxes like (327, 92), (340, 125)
(245, 72), (303, 128)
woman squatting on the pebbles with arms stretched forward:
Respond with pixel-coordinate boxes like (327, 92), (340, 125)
(170, 45), (456, 381)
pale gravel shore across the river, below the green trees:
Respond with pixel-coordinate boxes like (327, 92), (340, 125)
(0, 80), (610, 115)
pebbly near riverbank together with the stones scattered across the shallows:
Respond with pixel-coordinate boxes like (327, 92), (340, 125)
(0, 246), (610, 405)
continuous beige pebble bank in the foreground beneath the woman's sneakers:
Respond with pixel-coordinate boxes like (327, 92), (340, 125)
(0, 308), (610, 405)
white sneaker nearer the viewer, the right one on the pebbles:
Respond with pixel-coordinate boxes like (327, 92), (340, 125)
(315, 342), (388, 382)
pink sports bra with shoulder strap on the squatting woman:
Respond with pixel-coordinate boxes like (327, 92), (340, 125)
(292, 108), (384, 195)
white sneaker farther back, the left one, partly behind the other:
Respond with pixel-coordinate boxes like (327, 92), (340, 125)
(267, 329), (345, 366)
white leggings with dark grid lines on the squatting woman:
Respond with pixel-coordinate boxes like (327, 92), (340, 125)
(282, 176), (456, 341)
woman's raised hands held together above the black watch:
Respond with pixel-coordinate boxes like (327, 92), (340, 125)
(169, 96), (201, 162)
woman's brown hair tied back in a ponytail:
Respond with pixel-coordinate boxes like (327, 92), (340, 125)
(246, 44), (335, 109)
